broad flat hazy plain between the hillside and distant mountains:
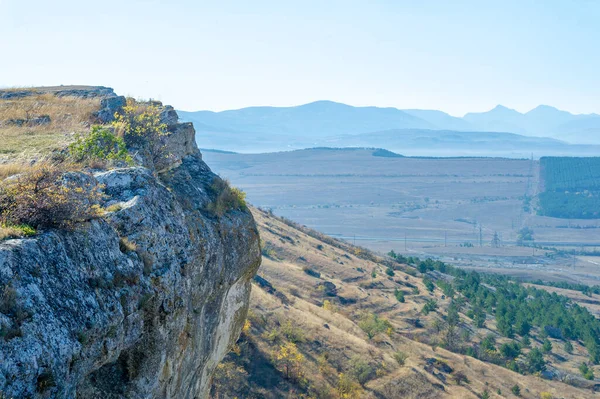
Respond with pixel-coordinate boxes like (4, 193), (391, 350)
(203, 149), (600, 284)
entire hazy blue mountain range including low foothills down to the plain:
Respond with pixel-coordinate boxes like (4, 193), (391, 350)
(178, 101), (600, 155)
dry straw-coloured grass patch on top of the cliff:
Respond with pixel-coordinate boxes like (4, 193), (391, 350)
(0, 93), (100, 160)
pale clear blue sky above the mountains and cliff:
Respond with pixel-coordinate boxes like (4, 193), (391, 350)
(0, 0), (600, 116)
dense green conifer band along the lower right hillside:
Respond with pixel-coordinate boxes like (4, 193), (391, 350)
(389, 251), (600, 364)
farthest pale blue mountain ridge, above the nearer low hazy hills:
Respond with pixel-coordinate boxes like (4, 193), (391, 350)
(178, 101), (600, 144)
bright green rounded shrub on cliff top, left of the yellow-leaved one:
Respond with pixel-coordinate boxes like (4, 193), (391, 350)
(69, 126), (133, 164)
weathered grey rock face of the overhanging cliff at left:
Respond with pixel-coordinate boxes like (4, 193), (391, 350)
(0, 91), (260, 399)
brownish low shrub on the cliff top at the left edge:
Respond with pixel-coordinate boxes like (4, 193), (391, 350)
(0, 165), (103, 229)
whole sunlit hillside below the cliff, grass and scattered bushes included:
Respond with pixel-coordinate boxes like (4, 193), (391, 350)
(212, 209), (595, 398)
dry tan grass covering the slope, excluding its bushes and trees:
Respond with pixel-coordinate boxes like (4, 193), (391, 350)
(211, 209), (593, 399)
